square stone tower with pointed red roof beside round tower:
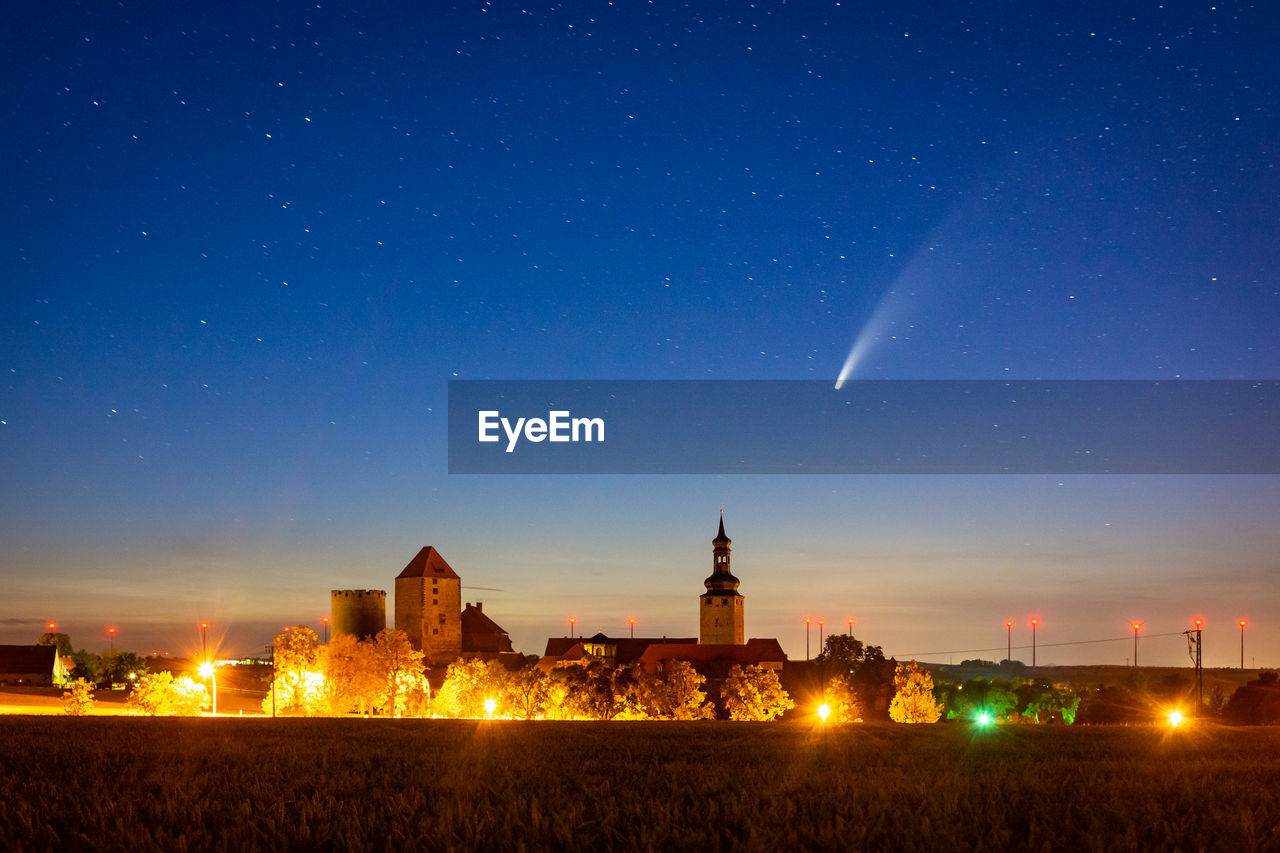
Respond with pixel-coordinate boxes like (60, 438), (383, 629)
(396, 546), (462, 665)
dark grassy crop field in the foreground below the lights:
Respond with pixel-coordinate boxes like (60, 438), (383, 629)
(0, 716), (1280, 850)
